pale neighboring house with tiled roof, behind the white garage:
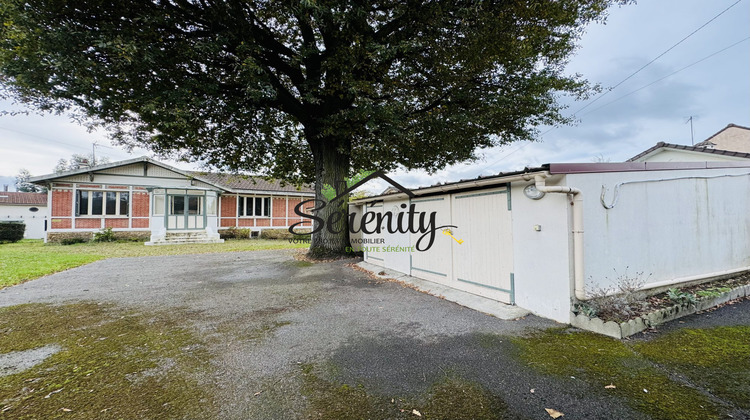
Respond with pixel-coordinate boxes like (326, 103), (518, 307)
(627, 124), (750, 162)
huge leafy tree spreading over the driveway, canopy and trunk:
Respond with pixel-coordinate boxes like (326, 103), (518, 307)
(0, 0), (624, 252)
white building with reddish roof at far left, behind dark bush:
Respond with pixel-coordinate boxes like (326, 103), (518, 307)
(0, 191), (49, 239)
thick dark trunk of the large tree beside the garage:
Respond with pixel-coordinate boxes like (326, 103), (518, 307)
(309, 138), (351, 258)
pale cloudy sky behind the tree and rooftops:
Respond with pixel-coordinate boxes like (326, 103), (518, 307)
(0, 0), (750, 191)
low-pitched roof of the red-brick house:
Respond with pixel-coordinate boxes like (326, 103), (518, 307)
(29, 156), (314, 193)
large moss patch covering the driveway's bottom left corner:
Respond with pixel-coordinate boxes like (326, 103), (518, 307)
(0, 303), (215, 419)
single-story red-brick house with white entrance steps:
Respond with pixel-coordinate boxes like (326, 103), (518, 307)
(31, 157), (314, 244)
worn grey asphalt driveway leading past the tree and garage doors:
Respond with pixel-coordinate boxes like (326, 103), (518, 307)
(0, 251), (748, 419)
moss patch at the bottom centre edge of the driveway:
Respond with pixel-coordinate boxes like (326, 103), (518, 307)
(302, 364), (510, 420)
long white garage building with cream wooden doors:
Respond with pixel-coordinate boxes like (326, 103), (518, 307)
(353, 160), (750, 323)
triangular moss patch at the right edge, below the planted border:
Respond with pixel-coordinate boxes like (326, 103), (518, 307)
(634, 326), (750, 408)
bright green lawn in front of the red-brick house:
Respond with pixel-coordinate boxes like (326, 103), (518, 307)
(0, 239), (307, 288)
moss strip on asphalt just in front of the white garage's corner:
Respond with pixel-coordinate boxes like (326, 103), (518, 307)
(513, 329), (720, 420)
